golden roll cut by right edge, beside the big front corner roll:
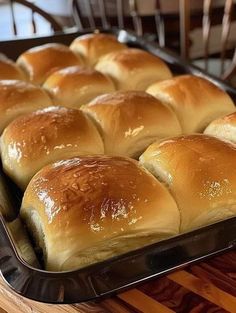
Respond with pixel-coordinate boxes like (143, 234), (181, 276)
(140, 134), (236, 232)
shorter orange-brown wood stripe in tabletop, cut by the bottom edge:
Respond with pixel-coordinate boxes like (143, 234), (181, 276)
(118, 289), (174, 313)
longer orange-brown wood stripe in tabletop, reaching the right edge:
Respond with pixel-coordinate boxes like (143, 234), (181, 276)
(168, 271), (236, 313)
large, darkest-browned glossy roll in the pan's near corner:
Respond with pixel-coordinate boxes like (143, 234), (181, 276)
(21, 156), (180, 271)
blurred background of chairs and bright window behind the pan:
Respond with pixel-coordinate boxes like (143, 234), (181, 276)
(0, 0), (236, 80)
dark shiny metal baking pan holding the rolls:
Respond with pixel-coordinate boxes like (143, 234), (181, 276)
(0, 30), (236, 304)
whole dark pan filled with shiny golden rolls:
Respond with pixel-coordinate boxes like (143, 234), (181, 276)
(0, 30), (236, 303)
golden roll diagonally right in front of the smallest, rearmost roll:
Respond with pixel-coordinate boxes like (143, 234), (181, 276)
(96, 49), (172, 90)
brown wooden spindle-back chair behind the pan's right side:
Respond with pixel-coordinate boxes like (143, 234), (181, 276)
(72, 0), (236, 80)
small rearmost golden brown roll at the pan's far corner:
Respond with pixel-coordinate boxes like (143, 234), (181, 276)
(70, 33), (127, 66)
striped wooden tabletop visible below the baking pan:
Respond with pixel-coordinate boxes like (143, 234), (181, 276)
(0, 251), (236, 313)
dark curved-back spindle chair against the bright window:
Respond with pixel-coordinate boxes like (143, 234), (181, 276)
(1, 0), (62, 36)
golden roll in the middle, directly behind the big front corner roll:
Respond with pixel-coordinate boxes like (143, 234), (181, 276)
(82, 91), (181, 158)
